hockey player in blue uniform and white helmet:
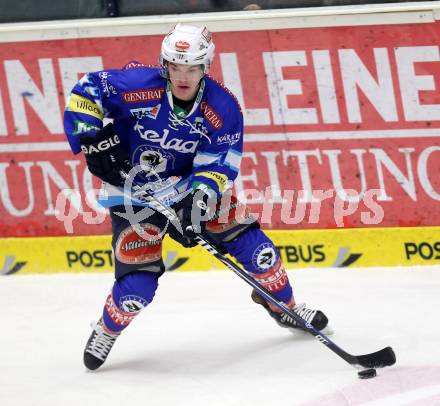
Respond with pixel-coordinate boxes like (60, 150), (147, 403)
(65, 24), (328, 370)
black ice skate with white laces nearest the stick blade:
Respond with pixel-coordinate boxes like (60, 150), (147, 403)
(251, 290), (333, 334)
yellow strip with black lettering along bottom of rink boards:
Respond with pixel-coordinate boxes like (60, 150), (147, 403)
(0, 227), (440, 275)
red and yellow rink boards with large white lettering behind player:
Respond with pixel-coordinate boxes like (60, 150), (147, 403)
(0, 2), (440, 275)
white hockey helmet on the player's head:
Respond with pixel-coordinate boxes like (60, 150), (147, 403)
(159, 24), (215, 78)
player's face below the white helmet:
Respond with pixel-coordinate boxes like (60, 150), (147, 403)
(168, 63), (203, 100)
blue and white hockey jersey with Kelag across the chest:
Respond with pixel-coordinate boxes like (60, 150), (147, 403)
(64, 64), (243, 206)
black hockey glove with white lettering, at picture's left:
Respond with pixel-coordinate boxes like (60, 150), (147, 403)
(80, 123), (132, 186)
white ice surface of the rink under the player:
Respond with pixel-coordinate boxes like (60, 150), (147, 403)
(0, 267), (440, 406)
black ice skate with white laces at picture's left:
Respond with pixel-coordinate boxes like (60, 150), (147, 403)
(84, 318), (120, 371)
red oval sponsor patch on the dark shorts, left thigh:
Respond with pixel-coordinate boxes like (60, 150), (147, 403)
(115, 224), (162, 264)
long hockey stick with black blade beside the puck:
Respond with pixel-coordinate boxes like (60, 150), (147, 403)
(120, 171), (396, 368)
